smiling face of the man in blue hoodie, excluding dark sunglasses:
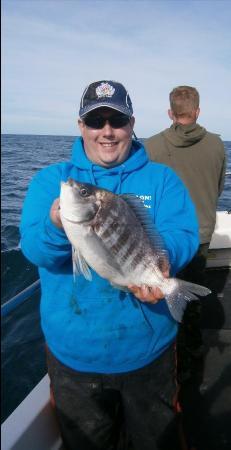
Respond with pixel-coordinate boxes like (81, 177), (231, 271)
(78, 108), (135, 167)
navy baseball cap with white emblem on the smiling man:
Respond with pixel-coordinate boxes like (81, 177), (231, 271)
(79, 80), (133, 118)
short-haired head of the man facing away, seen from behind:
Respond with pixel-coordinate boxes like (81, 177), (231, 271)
(169, 86), (200, 117)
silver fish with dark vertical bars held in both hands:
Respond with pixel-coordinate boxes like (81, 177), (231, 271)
(60, 178), (211, 322)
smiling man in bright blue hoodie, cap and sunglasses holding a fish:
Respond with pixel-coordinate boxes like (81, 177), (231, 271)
(21, 80), (199, 450)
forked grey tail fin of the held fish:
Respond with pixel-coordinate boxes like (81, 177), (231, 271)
(165, 278), (211, 322)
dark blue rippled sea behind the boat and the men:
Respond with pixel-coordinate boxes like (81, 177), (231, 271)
(1, 134), (231, 422)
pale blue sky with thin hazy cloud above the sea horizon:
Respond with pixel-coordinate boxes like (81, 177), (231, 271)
(1, 0), (231, 140)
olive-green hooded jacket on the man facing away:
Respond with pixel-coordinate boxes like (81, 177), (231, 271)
(144, 123), (226, 244)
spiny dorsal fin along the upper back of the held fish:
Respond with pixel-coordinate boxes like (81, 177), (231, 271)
(120, 194), (169, 262)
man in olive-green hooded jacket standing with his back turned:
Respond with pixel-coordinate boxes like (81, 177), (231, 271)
(145, 86), (226, 381)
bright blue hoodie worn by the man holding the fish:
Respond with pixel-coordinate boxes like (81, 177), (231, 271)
(20, 138), (199, 373)
